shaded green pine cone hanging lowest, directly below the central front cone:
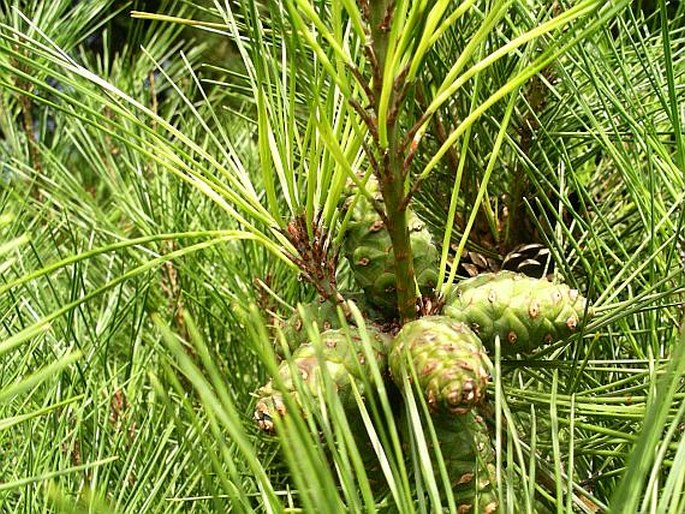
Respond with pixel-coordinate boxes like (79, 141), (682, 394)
(433, 410), (498, 514)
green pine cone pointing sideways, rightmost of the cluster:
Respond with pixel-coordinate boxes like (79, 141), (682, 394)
(443, 271), (592, 354)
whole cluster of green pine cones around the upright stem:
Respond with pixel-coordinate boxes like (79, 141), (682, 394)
(255, 180), (592, 508)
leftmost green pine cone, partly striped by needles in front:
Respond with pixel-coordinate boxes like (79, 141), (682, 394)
(254, 327), (387, 432)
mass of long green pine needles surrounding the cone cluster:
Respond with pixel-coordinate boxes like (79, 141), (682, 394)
(0, 0), (685, 513)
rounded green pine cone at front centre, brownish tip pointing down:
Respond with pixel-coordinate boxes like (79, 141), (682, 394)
(388, 316), (490, 414)
